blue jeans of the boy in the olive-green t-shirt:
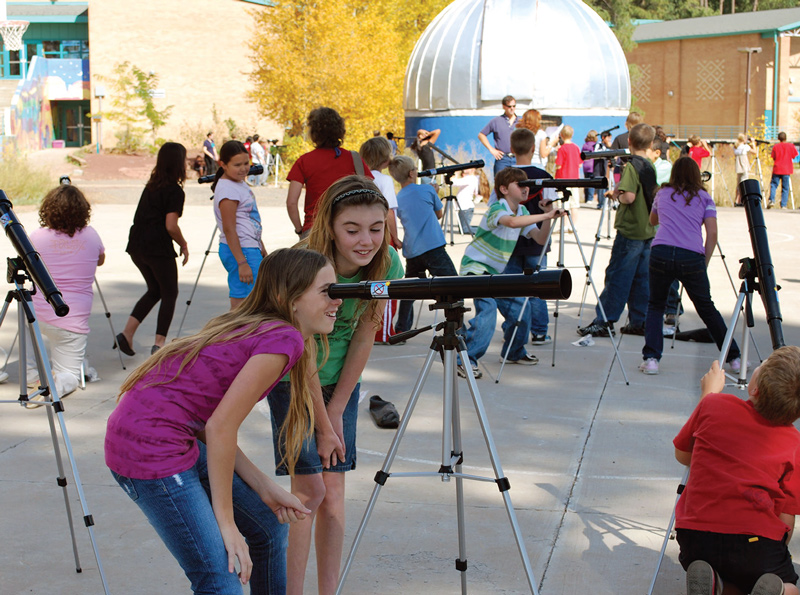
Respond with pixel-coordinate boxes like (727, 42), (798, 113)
(594, 232), (652, 326)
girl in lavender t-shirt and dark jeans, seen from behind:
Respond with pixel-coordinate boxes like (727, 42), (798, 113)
(639, 157), (741, 374)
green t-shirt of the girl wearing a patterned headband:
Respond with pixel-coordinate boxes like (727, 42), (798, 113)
(317, 247), (405, 386)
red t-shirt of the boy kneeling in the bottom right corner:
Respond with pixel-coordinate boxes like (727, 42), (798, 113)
(673, 394), (800, 541)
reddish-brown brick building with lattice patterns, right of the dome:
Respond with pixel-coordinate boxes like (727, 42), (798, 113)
(628, 8), (800, 138)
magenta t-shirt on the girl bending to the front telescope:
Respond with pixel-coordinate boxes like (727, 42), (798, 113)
(105, 322), (303, 479)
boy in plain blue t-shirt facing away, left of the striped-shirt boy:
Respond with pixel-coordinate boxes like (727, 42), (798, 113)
(389, 155), (458, 333)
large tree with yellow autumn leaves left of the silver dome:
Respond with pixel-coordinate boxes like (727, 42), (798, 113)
(250, 0), (450, 147)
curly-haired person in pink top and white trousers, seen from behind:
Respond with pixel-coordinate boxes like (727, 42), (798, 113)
(26, 184), (106, 408)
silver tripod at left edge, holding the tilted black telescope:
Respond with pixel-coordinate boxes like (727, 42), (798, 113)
(0, 258), (108, 595)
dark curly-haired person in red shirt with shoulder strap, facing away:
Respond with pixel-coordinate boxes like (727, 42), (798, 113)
(286, 107), (372, 239)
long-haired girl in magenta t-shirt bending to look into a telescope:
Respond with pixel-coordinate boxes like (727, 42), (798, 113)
(105, 249), (341, 595)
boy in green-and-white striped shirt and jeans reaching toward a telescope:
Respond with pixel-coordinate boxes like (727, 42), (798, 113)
(458, 167), (563, 379)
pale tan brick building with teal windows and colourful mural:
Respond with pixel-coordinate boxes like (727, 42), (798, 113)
(0, 0), (283, 150)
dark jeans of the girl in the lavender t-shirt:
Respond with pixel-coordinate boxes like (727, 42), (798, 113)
(642, 245), (740, 361)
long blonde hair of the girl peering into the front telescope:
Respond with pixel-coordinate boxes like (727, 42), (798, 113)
(118, 248), (332, 474)
